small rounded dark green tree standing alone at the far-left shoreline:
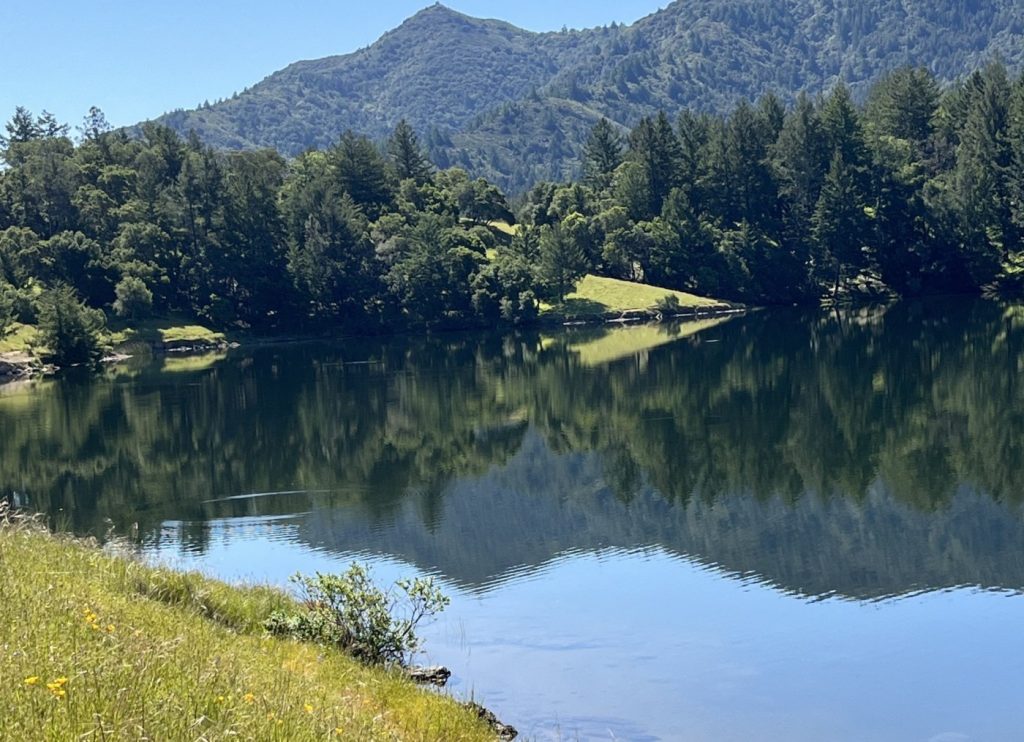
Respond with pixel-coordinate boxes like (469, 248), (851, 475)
(39, 286), (106, 366)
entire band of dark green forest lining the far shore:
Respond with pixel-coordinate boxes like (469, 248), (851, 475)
(6, 62), (1024, 355)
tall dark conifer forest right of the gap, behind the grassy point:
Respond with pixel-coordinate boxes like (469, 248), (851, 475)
(522, 62), (1024, 303)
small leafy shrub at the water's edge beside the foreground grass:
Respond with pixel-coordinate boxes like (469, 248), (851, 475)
(266, 564), (449, 665)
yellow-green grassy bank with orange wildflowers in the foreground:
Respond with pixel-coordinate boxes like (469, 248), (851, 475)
(0, 515), (493, 740)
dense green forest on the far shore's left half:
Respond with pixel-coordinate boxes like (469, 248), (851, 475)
(0, 103), (539, 358)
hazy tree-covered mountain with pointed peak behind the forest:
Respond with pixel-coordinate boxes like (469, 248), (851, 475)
(155, 0), (1024, 191)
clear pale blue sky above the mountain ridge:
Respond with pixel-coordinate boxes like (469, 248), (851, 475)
(0, 0), (668, 131)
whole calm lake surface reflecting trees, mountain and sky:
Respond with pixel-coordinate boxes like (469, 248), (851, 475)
(0, 300), (1024, 742)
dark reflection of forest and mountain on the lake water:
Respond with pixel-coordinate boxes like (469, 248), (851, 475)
(0, 302), (1024, 600)
